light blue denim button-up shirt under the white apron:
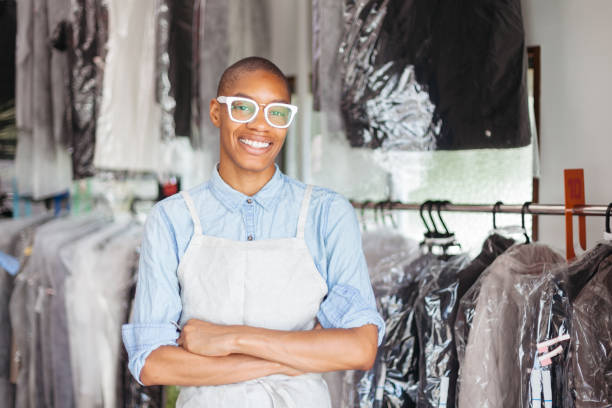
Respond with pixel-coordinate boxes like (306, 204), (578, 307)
(123, 166), (385, 381)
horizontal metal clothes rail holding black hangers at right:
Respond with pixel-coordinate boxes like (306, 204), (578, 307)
(351, 201), (608, 216)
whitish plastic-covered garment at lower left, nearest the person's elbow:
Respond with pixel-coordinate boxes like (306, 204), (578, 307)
(60, 222), (142, 407)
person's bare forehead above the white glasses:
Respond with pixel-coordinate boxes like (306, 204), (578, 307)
(226, 70), (291, 103)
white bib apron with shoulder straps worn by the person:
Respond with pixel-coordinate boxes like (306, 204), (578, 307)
(176, 186), (331, 408)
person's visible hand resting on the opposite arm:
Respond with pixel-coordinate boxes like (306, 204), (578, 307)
(177, 319), (235, 357)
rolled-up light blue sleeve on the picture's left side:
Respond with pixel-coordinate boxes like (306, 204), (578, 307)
(122, 204), (182, 384)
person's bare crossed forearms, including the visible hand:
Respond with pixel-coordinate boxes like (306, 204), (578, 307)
(140, 319), (378, 386)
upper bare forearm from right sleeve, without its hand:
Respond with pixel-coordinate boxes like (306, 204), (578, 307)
(233, 325), (378, 372)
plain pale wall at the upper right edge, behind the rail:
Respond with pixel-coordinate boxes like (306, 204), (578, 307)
(522, 0), (612, 253)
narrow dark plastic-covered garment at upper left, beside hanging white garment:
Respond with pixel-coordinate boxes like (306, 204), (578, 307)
(68, 0), (108, 179)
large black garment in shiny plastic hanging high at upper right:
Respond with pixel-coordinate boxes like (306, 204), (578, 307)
(328, 0), (531, 151)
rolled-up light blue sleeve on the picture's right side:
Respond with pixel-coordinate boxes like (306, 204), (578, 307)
(317, 195), (385, 345)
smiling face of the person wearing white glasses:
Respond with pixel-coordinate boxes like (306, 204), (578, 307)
(210, 70), (290, 178)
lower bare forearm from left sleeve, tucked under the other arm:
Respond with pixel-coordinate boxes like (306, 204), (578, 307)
(140, 346), (297, 386)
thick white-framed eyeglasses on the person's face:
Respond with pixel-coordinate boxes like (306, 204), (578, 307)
(217, 96), (297, 129)
